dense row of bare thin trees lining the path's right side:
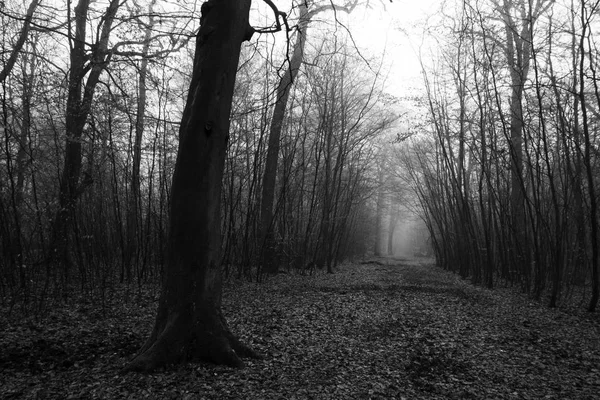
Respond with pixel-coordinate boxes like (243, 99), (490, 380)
(404, 0), (598, 311)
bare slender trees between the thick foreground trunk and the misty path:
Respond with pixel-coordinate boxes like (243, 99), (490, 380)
(218, 5), (394, 275)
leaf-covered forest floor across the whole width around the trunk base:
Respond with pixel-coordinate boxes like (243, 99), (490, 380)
(0, 259), (600, 399)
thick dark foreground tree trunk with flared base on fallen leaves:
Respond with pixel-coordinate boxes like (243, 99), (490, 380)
(125, 0), (255, 371)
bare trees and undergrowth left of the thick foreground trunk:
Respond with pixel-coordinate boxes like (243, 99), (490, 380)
(0, 1), (198, 304)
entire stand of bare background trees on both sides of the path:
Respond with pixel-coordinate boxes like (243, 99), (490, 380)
(7, 0), (600, 318)
